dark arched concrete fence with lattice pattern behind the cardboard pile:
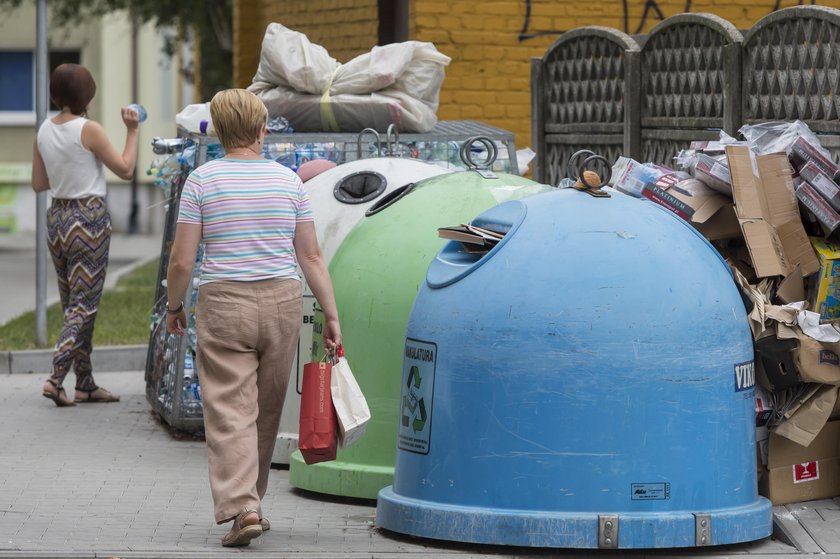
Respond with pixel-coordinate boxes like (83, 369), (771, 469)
(531, 6), (840, 185)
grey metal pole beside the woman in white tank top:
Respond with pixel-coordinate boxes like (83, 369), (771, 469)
(35, 0), (49, 346)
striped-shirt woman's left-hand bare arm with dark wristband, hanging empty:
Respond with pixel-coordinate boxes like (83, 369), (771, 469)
(166, 223), (201, 336)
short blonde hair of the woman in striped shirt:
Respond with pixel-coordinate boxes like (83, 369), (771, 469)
(210, 89), (268, 150)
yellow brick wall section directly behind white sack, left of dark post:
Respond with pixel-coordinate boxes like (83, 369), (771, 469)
(233, 0), (379, 87)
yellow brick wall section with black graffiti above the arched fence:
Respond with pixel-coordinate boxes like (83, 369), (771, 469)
(411, 0), (840, 165)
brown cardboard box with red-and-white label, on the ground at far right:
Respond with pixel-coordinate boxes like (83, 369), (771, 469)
(758, 421), (840, 505)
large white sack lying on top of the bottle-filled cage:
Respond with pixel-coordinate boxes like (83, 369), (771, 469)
(248, 23), (451, 132)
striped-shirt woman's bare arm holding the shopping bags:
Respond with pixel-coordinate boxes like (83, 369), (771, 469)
(294, 221), (341, 351)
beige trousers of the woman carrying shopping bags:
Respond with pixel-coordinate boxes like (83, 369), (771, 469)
(195, 279), (302, 524)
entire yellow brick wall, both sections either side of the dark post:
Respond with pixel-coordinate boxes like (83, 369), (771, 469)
(234, 0), (840, 170)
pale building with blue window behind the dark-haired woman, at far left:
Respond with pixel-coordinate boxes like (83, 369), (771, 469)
(0, 2), (193, 235)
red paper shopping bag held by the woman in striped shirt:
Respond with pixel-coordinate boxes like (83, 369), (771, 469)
(298, 361), (338, 464)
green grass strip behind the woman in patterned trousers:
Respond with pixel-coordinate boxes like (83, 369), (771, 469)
(0, 260), (159, 351)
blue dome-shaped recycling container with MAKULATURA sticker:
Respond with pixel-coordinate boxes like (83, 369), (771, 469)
(376, 189), (772, 549)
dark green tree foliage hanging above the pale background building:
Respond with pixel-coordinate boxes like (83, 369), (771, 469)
(0, 0), (233, 100)
